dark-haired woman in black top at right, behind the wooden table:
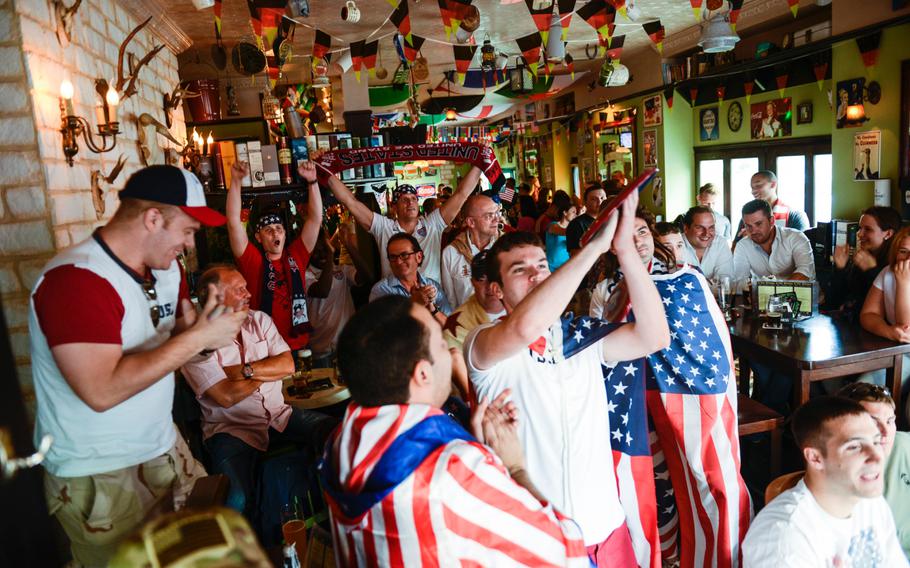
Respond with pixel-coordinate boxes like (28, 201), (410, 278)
(825, 206), (901, 323)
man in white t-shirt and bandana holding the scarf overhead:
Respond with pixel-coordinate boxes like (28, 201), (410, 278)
(329, 166), (480, 280)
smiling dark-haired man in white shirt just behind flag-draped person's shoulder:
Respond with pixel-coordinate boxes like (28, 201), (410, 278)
(683, 206), (733, 284)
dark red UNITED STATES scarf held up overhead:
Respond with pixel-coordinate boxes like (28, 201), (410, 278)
(313, 142), (506, 191)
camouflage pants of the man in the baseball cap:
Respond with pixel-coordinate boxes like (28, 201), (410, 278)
(44, 432), (205, 566)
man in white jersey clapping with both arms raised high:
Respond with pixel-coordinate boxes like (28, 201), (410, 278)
(465, 194), (670, 566)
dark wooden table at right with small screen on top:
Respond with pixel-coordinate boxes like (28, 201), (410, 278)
(730, 312), (910, 408)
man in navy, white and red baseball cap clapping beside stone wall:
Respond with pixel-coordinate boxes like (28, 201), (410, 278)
(29, 166), (247, 566)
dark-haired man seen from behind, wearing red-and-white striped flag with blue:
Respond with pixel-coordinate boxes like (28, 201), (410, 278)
(320, 297), (588, 566)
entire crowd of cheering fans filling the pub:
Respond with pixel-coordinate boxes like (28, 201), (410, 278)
(30, 156), (910, 566)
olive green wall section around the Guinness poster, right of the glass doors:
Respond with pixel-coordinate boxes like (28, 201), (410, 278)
(830, 24), (910, 219)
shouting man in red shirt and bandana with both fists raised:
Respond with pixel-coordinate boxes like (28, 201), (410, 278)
(225, 162), (322, 351)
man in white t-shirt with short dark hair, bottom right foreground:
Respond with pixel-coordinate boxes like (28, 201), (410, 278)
(743, 396), (910, 568)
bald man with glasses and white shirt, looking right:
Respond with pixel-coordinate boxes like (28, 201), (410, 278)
(440, 194), (502, 306)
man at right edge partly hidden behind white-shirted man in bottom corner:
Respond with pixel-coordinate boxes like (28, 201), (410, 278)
(837, 382), (910, 557)
